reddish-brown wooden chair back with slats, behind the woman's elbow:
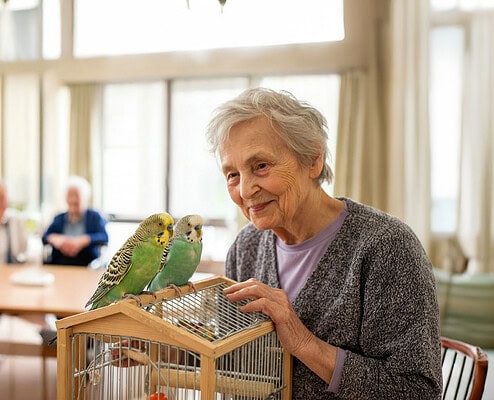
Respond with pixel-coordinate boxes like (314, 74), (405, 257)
(441, 337), (488, 400)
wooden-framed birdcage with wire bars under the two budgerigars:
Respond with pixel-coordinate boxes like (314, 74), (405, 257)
(57, 277), (292, 400)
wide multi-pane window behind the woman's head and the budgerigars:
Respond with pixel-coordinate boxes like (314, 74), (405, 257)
(100, 75), (339, 260)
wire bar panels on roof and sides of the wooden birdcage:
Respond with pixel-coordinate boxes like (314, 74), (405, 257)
(65, 283), (287, 400)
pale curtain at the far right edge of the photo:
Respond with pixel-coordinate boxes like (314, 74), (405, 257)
(458, 12), (494, 273)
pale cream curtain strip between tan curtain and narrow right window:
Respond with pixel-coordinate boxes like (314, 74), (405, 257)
(387, 0), (431, 249)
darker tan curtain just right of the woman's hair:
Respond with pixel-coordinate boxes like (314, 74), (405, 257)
(334, 1), (387, 210)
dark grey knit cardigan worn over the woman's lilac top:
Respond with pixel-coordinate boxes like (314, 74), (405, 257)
(225, 198), (442, 400)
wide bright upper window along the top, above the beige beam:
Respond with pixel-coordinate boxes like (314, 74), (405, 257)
(74, 0), (344, 57)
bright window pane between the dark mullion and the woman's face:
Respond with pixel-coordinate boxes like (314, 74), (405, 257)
(169, 78), (248, 220)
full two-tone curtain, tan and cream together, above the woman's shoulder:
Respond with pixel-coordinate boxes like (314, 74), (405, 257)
(335, 0), (431, 249)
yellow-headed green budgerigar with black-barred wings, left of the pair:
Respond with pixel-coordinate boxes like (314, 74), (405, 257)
(86, 213), (174, 310)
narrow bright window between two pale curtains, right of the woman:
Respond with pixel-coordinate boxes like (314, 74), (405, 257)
(430, 26), (464, 233)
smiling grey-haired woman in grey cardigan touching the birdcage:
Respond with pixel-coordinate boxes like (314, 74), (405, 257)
(208, 88), (441, 400)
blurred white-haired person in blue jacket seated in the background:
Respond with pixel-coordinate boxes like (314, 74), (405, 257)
(43, 176), (108, 265)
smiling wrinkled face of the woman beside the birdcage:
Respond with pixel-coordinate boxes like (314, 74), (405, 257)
(220, 117), (320, 236)
